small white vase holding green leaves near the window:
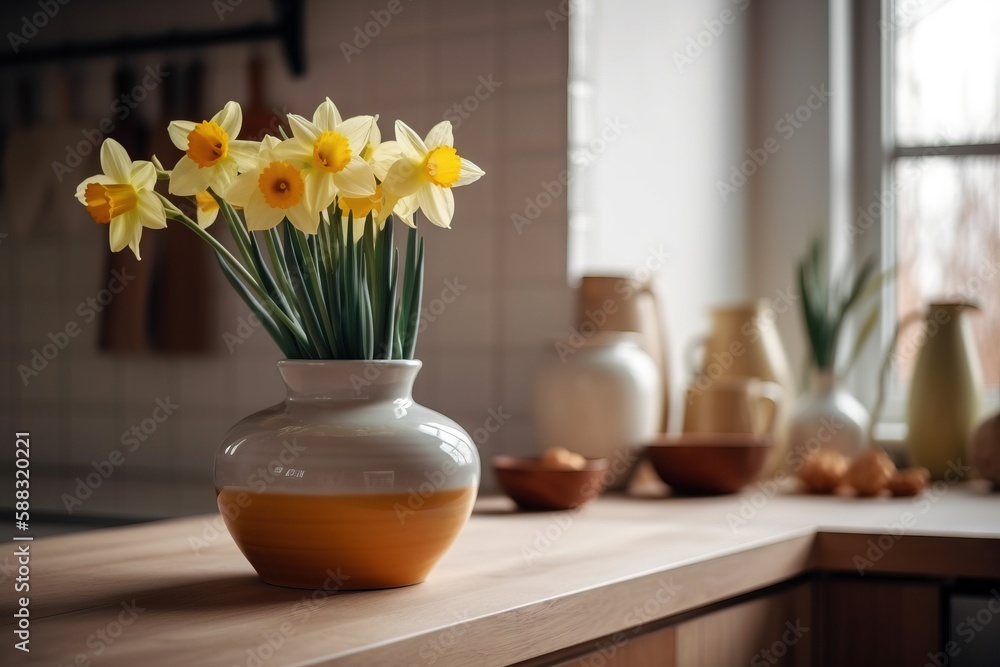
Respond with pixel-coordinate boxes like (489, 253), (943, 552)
(787, 369), (869, 464)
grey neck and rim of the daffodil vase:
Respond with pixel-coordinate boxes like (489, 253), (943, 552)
(278, 360), (421, 404)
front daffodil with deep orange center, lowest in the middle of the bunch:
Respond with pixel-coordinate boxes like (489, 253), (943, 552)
(226, 136), (319, 234)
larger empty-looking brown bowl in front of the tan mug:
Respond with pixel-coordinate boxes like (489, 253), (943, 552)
(646, 433), (772, 495)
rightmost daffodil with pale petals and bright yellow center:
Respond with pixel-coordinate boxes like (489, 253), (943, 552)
(376, 120), (485, 228)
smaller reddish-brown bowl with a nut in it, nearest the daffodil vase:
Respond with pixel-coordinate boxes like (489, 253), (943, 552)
(493, 456), (608, 510)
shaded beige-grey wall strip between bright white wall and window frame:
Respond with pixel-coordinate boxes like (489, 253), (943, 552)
(746, 0), (837, 386)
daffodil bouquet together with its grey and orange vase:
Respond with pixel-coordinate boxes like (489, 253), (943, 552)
(77, 99), (483, 588)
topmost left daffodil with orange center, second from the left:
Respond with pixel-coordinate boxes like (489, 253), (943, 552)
(168, 102), (260, 196)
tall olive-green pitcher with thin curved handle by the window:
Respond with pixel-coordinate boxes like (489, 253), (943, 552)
(872, 302), (982, 481)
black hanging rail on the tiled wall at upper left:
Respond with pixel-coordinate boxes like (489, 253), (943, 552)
(0, 0), (306, 76)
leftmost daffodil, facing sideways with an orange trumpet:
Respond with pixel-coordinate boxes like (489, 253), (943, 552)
(76, 139), (167, 259)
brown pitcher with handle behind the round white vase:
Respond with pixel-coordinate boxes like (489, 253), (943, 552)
(577, 276), (670, 432)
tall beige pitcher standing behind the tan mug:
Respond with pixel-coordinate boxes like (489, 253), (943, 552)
(687, 299), (796, 475)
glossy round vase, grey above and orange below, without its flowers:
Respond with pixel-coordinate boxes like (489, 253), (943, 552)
(215, 361), (480, 589)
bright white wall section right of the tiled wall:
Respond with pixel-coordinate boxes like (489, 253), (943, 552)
(570, 0), (752, 423)
